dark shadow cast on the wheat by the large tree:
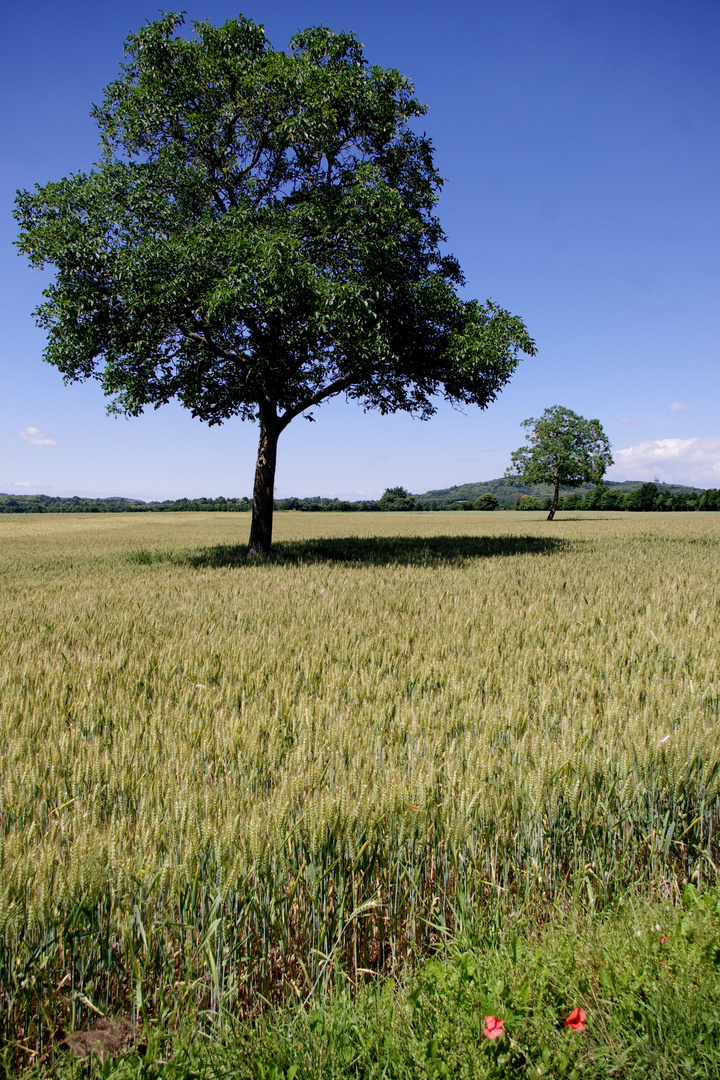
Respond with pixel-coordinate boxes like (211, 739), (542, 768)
(181, 536), (569, 569)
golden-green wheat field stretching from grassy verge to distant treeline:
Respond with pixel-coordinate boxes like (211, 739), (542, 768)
(0, 513), (720, 1053)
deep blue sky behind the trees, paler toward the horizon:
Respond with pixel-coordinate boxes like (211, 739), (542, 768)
(0, 0), (720, 499)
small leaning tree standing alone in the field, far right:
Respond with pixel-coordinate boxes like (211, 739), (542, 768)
(505, 405), (612, 522)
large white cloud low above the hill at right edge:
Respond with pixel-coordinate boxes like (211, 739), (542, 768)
(612, 438), (720, 487)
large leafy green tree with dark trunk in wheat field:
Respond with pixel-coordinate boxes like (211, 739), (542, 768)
(15, 6), (534, 554)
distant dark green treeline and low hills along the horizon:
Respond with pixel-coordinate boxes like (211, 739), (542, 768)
(0, 481), (720, 514)
